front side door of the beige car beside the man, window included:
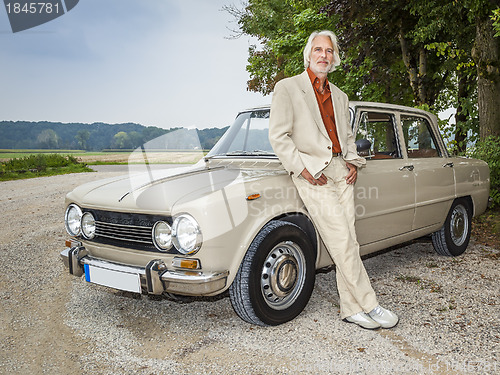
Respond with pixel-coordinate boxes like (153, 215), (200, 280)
(355, 108), (415, 245)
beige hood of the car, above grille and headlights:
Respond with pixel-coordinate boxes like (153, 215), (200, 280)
(67, 164), (284, 214)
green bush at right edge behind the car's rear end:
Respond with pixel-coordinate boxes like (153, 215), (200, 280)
(472, 136), (500, 207)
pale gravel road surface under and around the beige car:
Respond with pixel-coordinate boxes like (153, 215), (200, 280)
(0, 168), (500, 374)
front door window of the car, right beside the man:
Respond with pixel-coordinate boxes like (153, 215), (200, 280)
(356, 112), (401, 159)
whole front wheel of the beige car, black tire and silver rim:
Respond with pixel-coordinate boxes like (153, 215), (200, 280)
(229, 220), (316, 326)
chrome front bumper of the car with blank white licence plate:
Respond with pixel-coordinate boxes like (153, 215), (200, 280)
(61, 246), (229, 296)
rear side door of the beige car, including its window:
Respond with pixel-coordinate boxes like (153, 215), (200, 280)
(400, 113), (455, 230)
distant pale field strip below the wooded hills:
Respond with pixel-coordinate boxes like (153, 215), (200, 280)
(0, 149), (206, 164)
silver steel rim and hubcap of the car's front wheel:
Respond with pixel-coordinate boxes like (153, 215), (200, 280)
(260, 241), (306, 310)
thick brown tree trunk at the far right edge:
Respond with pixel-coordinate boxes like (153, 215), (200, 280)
(472, 17), (500, 139)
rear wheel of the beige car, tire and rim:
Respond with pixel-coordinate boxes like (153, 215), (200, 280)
(432, 199), (472, 257)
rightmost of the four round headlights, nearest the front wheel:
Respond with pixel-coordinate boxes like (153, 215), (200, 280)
(172, 215), (202, 254)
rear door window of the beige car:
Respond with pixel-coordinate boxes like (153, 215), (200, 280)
(401, 115), (441, 158)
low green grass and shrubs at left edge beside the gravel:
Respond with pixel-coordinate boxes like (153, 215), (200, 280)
(0, 153), (92, 181)
